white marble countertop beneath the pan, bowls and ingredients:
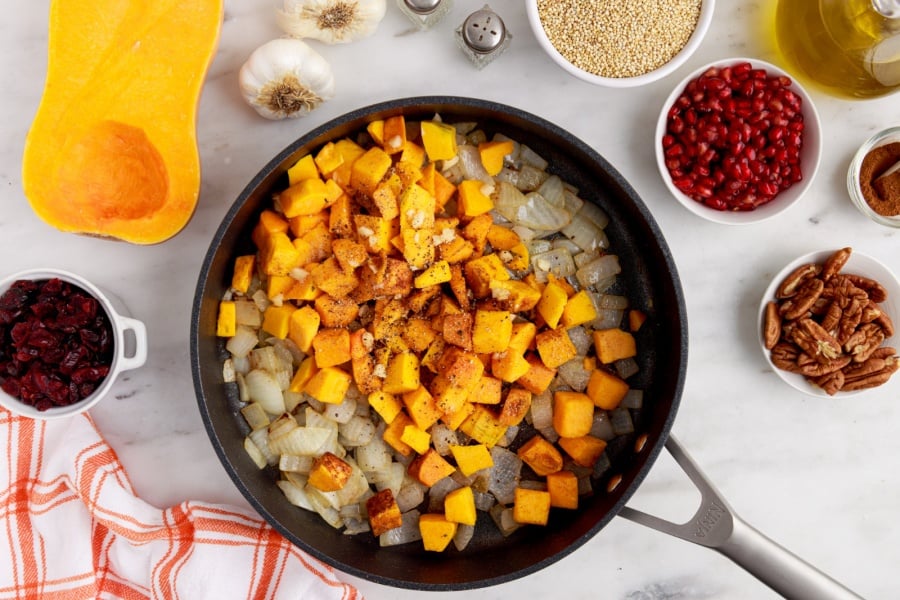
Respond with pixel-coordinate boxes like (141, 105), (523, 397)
(0, 0), (900, 600)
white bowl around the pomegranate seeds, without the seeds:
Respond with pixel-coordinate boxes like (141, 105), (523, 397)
(653, 57), (822, 225)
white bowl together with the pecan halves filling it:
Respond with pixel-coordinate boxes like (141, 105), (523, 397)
(759, 247), (900, 398)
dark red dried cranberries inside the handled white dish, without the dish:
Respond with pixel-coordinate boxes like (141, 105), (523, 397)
(0, 278), (113, 411)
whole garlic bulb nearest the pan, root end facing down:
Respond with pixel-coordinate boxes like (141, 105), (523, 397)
(239, 38), (334, 119)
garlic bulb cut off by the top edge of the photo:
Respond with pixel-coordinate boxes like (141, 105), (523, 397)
(277, 0), (386, 44)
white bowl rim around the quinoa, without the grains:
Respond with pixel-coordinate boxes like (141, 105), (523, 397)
(526, 0), (715, 88)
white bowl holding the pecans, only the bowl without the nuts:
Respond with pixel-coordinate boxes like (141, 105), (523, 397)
(757, 250), (900, 398)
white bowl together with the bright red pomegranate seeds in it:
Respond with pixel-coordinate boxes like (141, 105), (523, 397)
(655, 58), (822, 225)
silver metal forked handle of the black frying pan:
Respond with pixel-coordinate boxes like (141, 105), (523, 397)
(619, 435), (861, 600)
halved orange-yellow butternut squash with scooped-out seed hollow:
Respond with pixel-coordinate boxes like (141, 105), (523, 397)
(22, 0), (223, 244)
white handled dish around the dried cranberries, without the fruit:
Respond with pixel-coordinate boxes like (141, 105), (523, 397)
(0, 269), (147, 419)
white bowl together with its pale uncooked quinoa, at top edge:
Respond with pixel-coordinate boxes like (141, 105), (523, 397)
(527, 0), (715, 87)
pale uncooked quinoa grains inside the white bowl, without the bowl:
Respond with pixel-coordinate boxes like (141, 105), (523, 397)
(537, 0), (702, 78)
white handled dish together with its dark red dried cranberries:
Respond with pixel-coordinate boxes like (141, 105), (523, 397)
(0, 269), (147, 419)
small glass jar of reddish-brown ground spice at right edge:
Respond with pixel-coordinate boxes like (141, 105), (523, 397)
(847, 126), (900, 227)
